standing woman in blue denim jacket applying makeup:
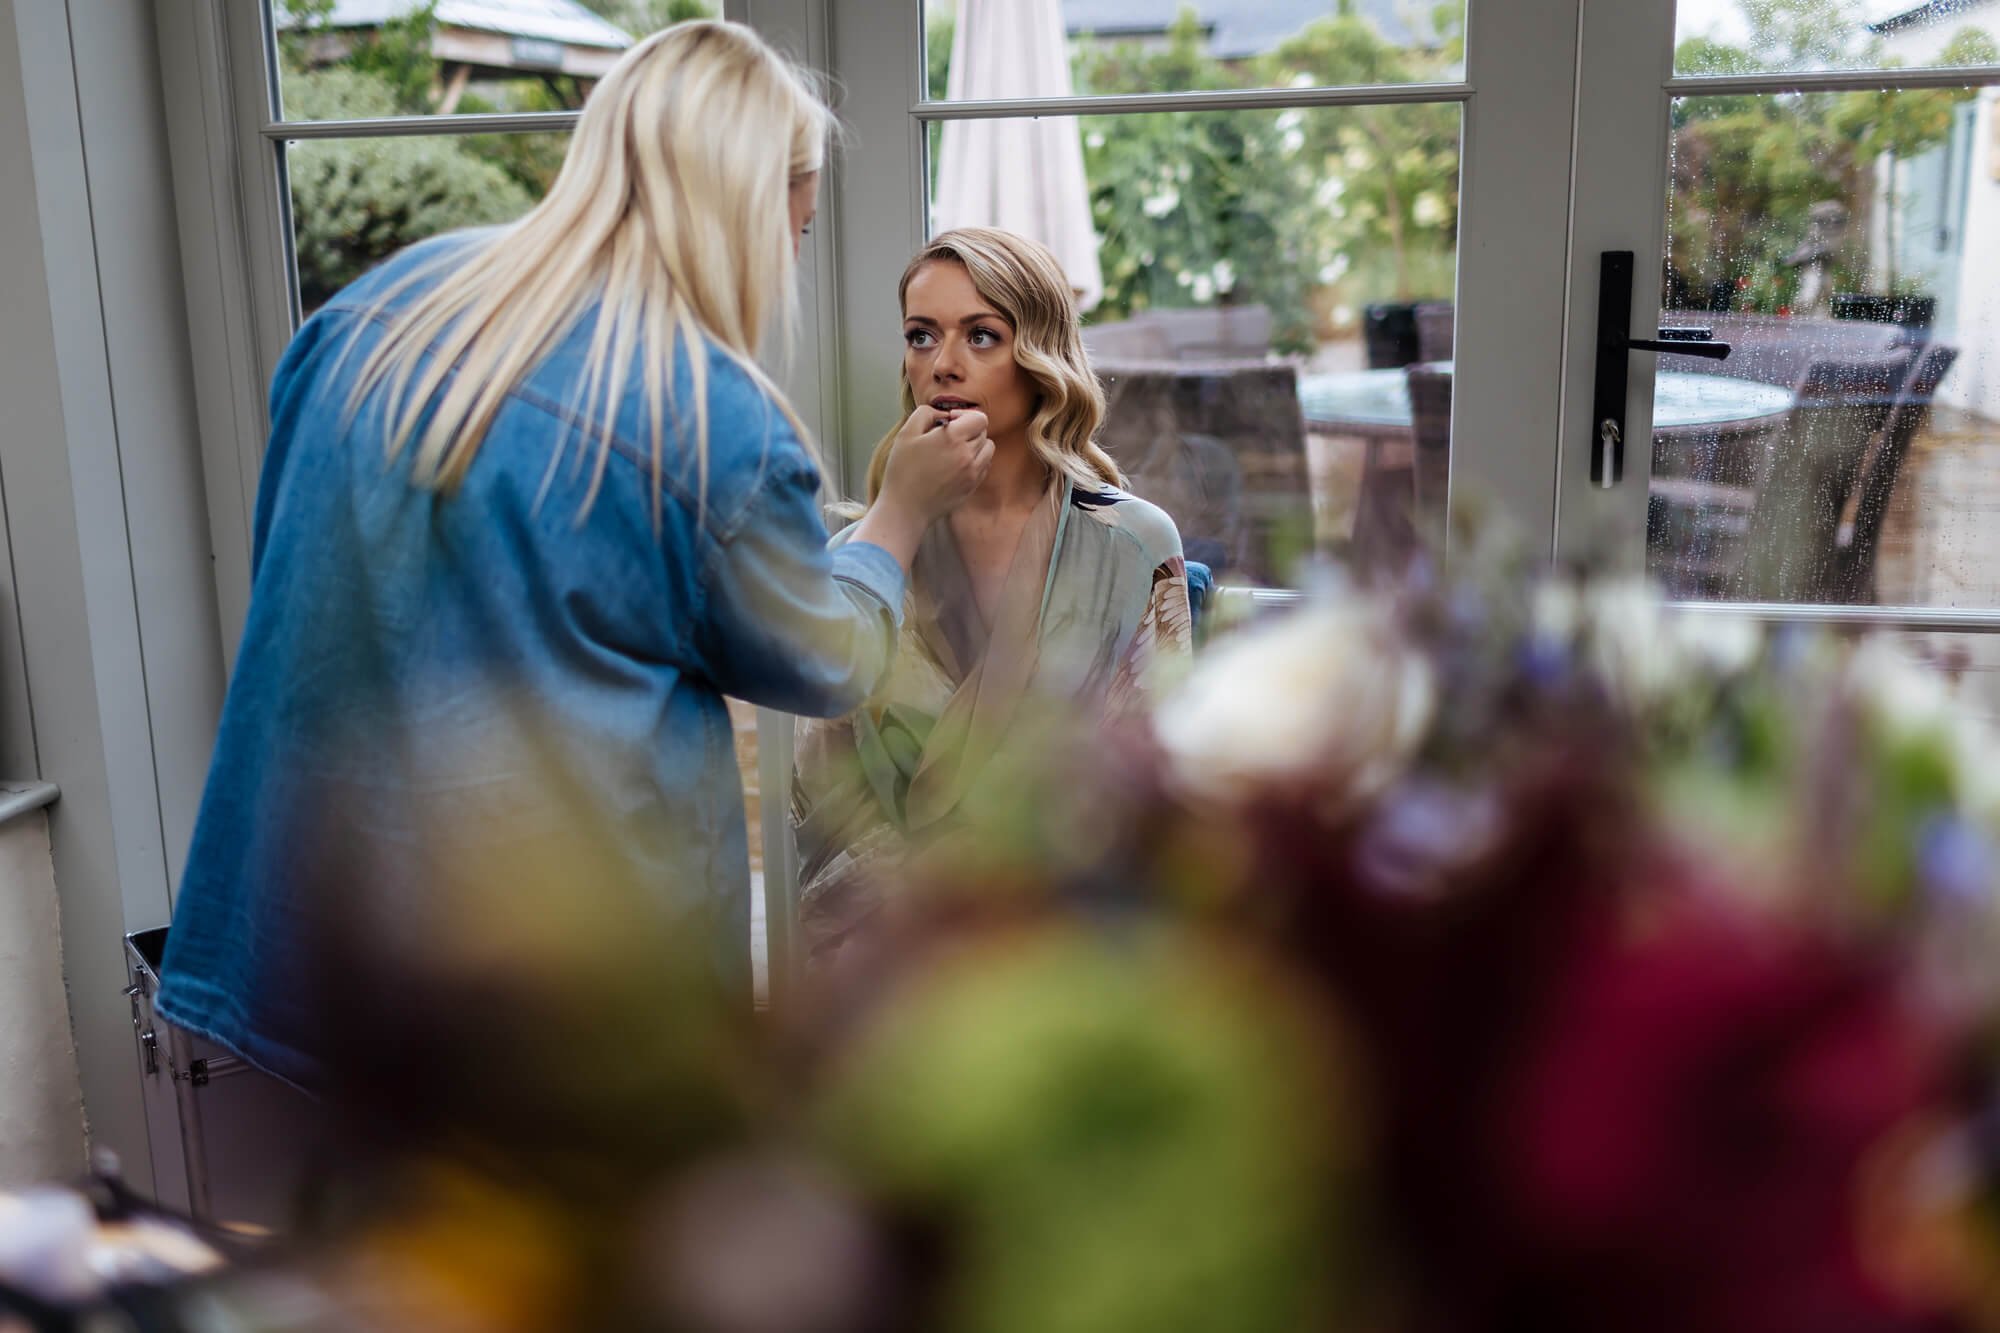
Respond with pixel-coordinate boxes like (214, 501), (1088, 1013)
(158, 22), (994, 1089)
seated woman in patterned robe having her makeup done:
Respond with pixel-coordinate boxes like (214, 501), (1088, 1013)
(792, 228), (1190, 961)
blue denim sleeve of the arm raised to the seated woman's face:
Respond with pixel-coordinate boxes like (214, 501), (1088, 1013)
(700, 458), (904, 717)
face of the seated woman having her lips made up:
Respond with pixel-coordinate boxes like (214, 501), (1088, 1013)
(902, 260), (1036, 444)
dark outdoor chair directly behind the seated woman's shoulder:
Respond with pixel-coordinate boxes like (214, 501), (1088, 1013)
(1096, 362), (1312, 584)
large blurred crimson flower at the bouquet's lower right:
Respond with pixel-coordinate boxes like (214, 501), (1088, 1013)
(1492, 897), (1940, 1333)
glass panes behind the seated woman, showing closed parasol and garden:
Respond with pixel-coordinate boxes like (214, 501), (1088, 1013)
(924, 0), (1464, 586)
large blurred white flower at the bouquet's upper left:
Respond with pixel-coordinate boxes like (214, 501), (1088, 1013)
(1154, 604), (1436, 807)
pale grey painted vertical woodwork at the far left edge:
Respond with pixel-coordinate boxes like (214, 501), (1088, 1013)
(0, 0), (222, 1189)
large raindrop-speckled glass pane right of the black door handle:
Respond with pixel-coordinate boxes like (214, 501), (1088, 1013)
(1646, 88), (2000, 608)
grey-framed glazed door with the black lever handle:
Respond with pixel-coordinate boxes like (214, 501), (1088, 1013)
(1556, 0), (2000, 624)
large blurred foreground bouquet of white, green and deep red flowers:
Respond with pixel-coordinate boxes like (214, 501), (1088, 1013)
(788, 560), (2000, 1333)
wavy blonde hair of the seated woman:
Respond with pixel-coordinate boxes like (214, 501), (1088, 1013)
(868, 226), (1124, 504)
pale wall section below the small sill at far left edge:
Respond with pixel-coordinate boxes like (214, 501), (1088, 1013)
(0, 811), (84, 1189)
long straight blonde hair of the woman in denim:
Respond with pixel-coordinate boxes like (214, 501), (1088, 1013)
(350, 22), (832, 522)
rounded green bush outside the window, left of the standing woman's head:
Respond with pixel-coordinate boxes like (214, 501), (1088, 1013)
(288, 68), (534, 310)
